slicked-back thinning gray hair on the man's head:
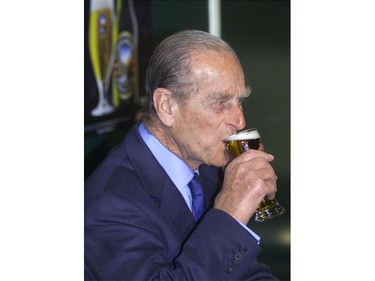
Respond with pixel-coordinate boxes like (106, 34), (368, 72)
(143, 30), (238, 118)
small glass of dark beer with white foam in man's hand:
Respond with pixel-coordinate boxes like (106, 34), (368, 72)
(225, 128), (284, 222)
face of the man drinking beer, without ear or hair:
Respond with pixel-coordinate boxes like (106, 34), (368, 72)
(171, 53), (249, 169)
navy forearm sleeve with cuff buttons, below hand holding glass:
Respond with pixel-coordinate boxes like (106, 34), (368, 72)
(176, 209), (277, 281)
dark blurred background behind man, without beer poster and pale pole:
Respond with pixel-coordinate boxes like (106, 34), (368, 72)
(84, 0), (291, 280)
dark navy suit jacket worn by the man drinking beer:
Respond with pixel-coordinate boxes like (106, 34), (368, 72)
(85, 123), (276, 281)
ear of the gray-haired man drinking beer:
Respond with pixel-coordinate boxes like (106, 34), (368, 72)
(153, 88), (177, 127)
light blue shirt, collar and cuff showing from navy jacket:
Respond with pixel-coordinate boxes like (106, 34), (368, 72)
(138, 122), (260, 244)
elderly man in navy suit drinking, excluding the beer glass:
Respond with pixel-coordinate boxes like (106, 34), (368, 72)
(85, 30), (277, 281)
